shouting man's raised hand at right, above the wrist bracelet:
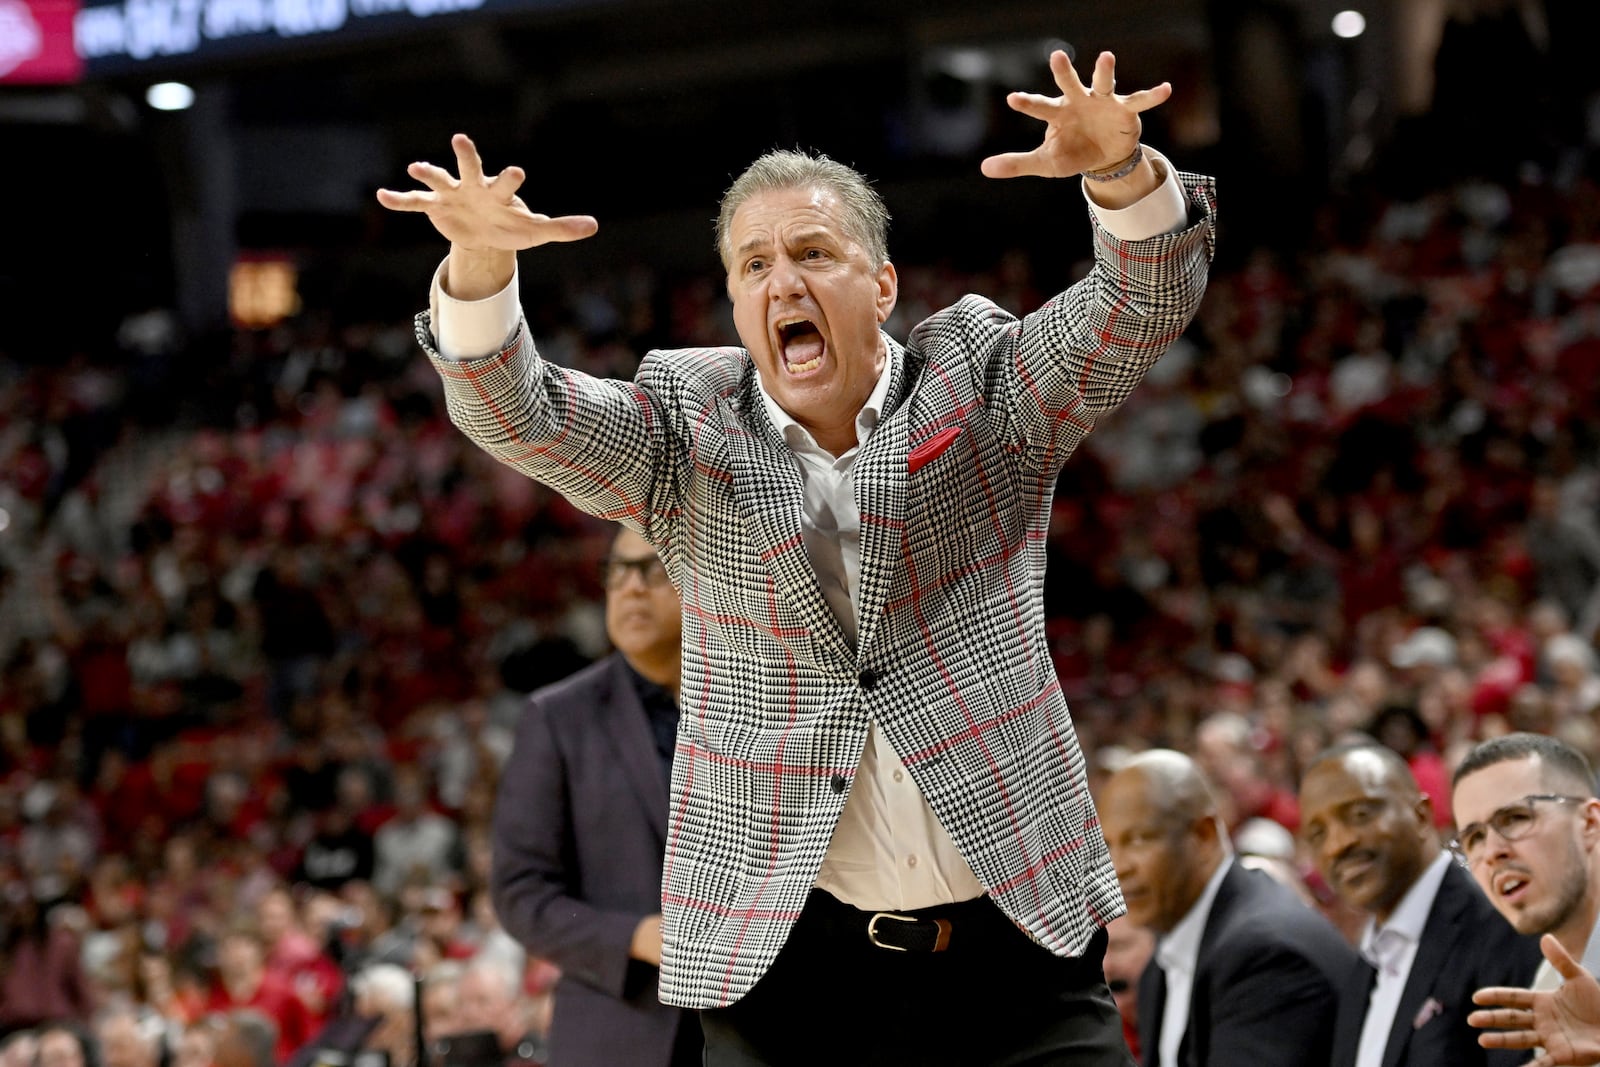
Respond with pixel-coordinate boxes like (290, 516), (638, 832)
(982, 50), (1173, 178)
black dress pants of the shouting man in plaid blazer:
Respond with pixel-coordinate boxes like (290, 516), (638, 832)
(701, 889), (1133, 1067)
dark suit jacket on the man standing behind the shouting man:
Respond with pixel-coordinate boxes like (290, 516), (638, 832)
(491, 654), (699, 1067)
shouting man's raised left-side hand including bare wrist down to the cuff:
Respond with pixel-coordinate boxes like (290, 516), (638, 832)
(378, 133), (598, 301)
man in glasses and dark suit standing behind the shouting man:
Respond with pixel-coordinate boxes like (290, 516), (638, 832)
(493, 530), (701, 1067)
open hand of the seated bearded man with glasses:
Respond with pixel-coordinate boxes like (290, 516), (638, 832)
(1467, 934), (1600, 1067)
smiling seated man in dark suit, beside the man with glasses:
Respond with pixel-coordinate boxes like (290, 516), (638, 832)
(1299, 742), (1539, 1067)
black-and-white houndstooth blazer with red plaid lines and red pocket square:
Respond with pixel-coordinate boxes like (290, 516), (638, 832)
(418, 174), (1214, 1008)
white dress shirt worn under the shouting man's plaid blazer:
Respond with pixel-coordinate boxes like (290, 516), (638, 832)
(429, 147), (1189, 915)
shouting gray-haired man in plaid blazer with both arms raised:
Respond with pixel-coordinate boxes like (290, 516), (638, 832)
(379, 43), (1214, 1067)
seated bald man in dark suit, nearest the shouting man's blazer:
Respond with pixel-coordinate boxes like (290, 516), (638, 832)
(1098, 750), (1357, 1067)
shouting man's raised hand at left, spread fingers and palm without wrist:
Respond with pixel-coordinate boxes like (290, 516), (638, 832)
(378, 133), (598, 253)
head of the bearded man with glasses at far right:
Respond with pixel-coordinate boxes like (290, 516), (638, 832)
(1451, 733), (1600, 1023)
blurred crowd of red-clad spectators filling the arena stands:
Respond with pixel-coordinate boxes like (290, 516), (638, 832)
(0, 99), (1600, 1067)
